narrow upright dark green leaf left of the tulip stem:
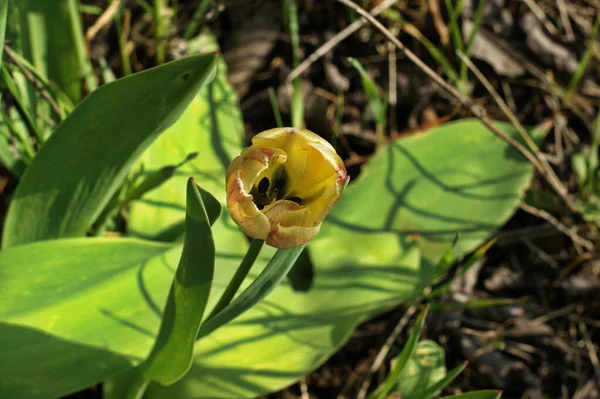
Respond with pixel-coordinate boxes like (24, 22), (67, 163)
(141, 178), (220, 385)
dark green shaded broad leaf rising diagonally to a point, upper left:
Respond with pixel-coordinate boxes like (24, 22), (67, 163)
(3, 55), (215, 248)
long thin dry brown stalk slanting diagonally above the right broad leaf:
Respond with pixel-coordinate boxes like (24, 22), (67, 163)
(337, 0), (577, 219)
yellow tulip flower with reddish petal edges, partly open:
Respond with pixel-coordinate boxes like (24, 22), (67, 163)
(227, 128), (349, 248)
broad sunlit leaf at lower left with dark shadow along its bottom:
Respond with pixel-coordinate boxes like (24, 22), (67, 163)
(0, 238), (179, 399)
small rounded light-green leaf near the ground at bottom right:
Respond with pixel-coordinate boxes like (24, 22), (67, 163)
(395, 340), (448, 399)
